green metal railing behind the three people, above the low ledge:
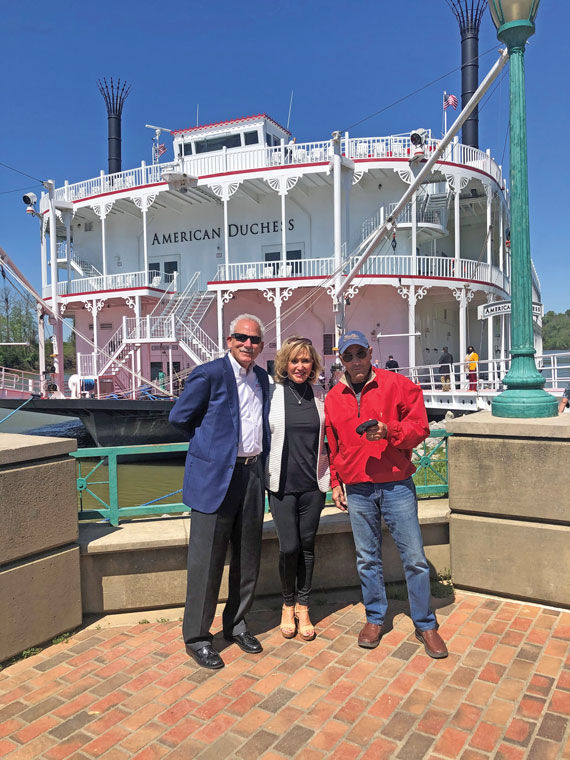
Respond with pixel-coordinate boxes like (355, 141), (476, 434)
(70, 430), (450, 526)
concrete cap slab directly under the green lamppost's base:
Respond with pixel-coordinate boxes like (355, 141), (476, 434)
(445, 412), (570, 440)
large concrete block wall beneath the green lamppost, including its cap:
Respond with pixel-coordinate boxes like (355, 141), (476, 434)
(447, 412), (570, 606)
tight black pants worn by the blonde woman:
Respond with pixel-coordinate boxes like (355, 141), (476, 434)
(269, 491), (325, 605)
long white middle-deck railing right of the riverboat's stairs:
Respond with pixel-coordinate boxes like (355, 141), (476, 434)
(214, 254), (509, 291)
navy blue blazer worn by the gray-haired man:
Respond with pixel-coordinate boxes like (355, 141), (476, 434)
(169, 356), (270, 514)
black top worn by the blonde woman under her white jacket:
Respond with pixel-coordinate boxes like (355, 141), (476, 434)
(279, 378), (320, 494)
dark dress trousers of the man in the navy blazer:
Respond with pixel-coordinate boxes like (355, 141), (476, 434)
(182, 458), (264, 649)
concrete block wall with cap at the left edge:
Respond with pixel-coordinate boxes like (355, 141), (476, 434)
(0, 434), (82, 662)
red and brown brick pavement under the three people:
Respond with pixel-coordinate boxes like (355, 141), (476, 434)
(0, 592), (570, 760)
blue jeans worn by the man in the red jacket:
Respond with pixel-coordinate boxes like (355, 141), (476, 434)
(346, 477), (437, 631)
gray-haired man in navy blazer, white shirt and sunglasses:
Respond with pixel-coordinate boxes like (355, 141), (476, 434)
(170, 314), (270, 668)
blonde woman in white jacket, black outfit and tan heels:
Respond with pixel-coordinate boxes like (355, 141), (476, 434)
(266, 336), (330, 641)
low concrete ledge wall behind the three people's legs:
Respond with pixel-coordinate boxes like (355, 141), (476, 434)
(79, 499), (450, 614)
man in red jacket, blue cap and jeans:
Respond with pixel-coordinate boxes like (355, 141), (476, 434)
(325, 330), (447, 659)
